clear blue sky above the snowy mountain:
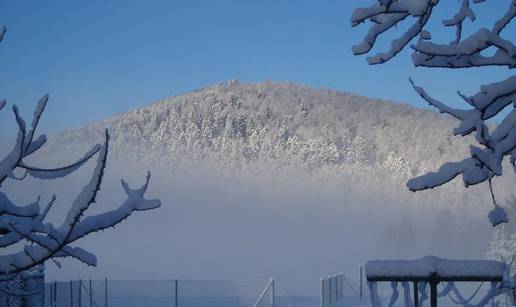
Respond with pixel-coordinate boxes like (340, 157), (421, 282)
(0, 0), (516, 132)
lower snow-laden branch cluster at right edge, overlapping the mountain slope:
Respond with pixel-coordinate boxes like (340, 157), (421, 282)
(407, 76), (516, 191)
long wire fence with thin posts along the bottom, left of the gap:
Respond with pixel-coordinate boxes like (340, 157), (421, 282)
(45, 279), (275, 307)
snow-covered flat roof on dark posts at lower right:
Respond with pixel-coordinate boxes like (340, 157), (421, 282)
(365, 256), (503, 281)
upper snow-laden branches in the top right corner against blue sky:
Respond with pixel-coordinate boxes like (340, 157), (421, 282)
(351, 0), (516, 68)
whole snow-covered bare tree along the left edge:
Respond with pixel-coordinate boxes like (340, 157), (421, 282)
(0, 27), (161, 284)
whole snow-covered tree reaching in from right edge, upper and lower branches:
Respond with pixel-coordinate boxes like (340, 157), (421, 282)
(351, 0), (516, 225)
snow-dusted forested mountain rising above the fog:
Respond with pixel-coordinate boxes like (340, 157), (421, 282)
(39, 80), (512, 213)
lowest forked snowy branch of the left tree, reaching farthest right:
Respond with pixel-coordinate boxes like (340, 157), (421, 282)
(0, 158), (161, 280)
